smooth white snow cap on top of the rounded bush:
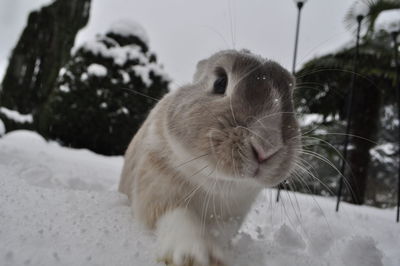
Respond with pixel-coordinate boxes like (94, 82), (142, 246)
(107, 19), (149, 45)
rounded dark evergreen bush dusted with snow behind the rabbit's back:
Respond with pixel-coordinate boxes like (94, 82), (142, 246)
(43, 21), (169, 154)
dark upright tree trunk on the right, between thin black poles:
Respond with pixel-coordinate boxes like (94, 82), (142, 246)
(346, 79), (381, 204)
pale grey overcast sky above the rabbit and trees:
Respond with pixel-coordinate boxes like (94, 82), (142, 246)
(0, 0), (354, 86)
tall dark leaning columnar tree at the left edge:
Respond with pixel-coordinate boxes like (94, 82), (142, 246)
(0, 0), (91, 131)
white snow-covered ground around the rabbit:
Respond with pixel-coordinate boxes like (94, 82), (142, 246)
(0, 131), (400, 266)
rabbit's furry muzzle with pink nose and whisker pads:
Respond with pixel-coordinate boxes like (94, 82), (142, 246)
(203, 123), (299, 187)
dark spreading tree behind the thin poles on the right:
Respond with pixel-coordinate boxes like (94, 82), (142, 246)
(296, 31), (396, 204)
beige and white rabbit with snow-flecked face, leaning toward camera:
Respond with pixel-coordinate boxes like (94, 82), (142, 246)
(119, 50), (301, 266)
